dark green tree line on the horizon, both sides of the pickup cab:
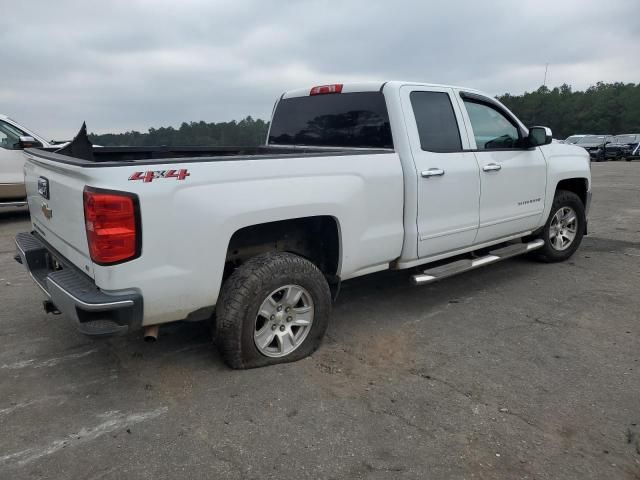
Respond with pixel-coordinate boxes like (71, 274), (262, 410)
(89, 82), (640, 146)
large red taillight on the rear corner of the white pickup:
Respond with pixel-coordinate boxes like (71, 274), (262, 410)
(84, 188), (140, 265)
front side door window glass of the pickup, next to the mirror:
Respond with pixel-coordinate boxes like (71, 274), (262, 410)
(464, 99), (520, 150)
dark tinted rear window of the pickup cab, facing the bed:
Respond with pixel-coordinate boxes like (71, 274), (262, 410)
(269, 92), (393, 148)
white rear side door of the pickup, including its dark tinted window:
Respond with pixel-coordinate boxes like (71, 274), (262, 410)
(400, 85), (480, 257)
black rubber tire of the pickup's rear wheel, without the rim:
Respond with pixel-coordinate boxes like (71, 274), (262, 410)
(214, 252), (331, 369)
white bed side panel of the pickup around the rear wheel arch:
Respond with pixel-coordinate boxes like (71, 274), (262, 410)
(85, 153), (403, 324)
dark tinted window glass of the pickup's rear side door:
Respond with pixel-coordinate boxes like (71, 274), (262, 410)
(410, 91), (462, 152)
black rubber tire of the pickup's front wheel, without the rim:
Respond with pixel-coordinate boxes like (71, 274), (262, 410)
(534, 190), (586, 263)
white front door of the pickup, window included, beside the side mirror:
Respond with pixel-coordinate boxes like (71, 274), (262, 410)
(456, 90), (547, 243)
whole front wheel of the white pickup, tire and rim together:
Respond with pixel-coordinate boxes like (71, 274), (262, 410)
(536, 190), (586, 262)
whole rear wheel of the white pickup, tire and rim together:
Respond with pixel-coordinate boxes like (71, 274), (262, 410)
(215, 252), (331, 368)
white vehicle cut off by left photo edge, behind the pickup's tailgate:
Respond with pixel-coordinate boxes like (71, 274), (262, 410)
(0, 115), (53, 207)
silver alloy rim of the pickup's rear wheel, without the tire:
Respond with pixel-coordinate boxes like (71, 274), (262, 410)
(253, 285), (314, 357)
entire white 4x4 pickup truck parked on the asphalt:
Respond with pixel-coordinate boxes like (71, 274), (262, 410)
(16, 82), (591, 368)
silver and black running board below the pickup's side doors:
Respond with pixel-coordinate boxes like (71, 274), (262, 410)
(411, 239), (544, 285)
